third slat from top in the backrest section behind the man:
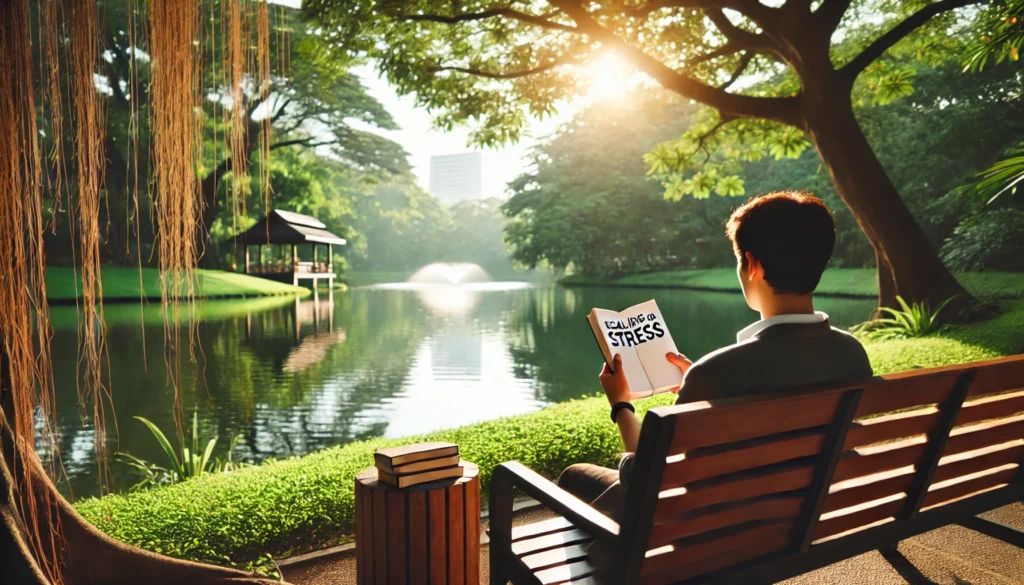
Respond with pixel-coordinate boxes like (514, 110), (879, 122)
(654, 463), (814, 517)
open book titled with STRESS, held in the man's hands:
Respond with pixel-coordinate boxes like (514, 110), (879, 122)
(587, 300), (682, 399)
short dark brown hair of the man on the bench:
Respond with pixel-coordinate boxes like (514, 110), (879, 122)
(725, 191), (836, 294)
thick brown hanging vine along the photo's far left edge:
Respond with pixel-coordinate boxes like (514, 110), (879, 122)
(0, 0), (61, 583)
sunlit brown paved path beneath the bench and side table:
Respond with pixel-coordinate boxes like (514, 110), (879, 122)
(284, 503), (1024, 585)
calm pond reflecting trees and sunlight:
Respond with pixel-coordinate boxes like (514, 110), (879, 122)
(41, 283), (873, 497)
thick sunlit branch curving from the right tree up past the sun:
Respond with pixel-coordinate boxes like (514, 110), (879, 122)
(552, 0), (803, 126)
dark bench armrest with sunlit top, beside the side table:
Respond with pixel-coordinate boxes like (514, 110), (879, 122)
(490, 461), (618, 538)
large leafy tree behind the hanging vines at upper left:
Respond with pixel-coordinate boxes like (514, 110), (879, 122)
(40, 0), (409, 264)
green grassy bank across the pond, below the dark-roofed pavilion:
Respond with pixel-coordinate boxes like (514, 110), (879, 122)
(46, 266), (309, 302)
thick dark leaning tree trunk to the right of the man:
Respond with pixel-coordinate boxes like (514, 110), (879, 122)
(806, 91), (970, 307)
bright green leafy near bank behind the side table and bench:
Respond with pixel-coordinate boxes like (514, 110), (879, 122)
(76, 299), (1024, 565)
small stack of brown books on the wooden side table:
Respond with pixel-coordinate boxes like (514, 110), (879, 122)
(374, 443), (462, 488)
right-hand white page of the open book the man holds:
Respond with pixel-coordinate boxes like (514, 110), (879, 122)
(620, 300), (683, 391)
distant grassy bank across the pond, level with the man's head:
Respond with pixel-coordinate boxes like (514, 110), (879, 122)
(560, 268), (1024, 297)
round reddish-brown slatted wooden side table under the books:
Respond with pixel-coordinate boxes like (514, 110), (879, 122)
(355, 461), (480, 585)
